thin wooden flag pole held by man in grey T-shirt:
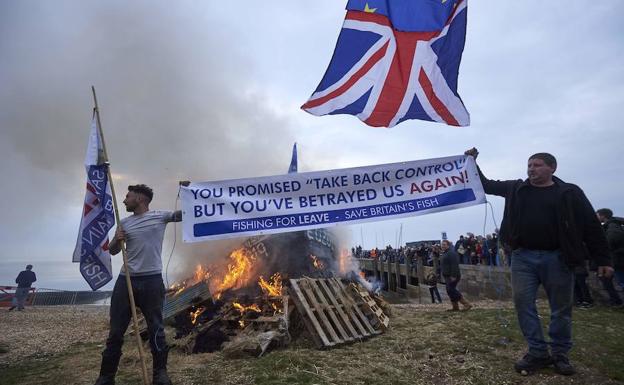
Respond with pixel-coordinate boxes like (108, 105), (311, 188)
(91, 86), (149, 385)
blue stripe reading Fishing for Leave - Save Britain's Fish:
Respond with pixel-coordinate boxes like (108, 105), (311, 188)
(193, 189), (476, 237)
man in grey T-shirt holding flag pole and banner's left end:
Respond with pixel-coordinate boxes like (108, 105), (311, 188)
(96, 184), (182, 385)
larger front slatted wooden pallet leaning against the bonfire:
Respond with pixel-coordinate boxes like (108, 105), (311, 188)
(290, 277), (381, 348)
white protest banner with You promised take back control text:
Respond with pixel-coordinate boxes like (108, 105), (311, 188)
(181, 155), (485, 242)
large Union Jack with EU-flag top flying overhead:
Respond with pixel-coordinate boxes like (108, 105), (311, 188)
(301, 0), (470, 127)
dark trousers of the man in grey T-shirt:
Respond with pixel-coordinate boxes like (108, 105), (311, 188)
(102, 274), (167, 356)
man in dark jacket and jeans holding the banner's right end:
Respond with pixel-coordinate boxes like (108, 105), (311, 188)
(466, 148), (613, 375)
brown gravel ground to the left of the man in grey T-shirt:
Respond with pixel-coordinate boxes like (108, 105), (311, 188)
(0, 305), (109, 366)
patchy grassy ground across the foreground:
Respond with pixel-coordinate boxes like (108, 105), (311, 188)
(0, 303), (624, 385)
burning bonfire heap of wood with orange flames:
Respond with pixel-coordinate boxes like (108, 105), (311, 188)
(161, 230), (388, 355)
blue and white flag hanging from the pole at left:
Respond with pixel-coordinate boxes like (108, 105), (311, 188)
(73, 116), (115, 290)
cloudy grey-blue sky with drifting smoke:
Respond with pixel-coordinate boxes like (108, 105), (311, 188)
(0, 0), (624, 289)
